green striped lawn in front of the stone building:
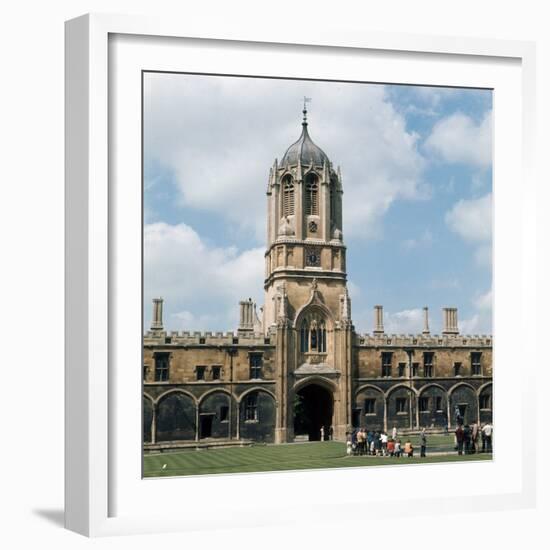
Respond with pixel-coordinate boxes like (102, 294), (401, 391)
(143, 442), (492, 477)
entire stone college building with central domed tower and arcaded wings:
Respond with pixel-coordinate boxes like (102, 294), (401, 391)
(143, 110), (493, 448)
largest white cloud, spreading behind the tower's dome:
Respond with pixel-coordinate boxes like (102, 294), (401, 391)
(145, 74), (427, 240)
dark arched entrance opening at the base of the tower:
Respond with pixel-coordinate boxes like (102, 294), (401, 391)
(294, 384), (334, 441)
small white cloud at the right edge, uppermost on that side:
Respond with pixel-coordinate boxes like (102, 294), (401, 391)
(425, 111), (493, 167)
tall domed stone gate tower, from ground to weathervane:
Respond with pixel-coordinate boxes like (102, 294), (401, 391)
(263, 105), (352, 442)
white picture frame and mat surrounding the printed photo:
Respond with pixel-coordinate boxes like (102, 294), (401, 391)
(65, 15), (536, 536)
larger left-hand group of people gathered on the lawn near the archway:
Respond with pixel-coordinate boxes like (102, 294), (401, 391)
(346, 427), (427, 458)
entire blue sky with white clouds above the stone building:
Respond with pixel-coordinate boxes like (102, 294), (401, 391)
(144, 73), (492, 334)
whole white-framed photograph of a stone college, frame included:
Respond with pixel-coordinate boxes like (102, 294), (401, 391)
(66, 16), (535, 536)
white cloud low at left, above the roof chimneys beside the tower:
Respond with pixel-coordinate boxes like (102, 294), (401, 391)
(144, 223), (264, 330)
